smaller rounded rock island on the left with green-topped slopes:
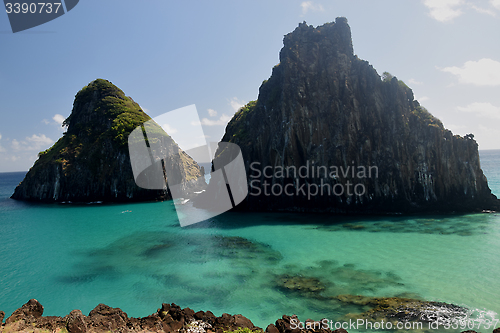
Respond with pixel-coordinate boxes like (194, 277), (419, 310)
(12, 79), (201, 202)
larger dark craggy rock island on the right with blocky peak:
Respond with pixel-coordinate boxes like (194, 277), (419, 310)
(217, 18), (499, 213)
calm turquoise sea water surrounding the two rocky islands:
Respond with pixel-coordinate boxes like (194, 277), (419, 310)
(0, 150), (500, 331)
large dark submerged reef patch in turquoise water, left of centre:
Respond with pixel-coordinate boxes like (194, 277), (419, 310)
(56, 232), (282, 298)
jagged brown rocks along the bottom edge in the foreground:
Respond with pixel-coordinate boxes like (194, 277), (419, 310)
(0, 299), (500, 333)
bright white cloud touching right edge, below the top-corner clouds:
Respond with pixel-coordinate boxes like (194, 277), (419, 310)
(441, 58), (500, 86)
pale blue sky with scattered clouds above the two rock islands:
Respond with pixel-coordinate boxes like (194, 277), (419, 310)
(0, 0), (500, 172)
